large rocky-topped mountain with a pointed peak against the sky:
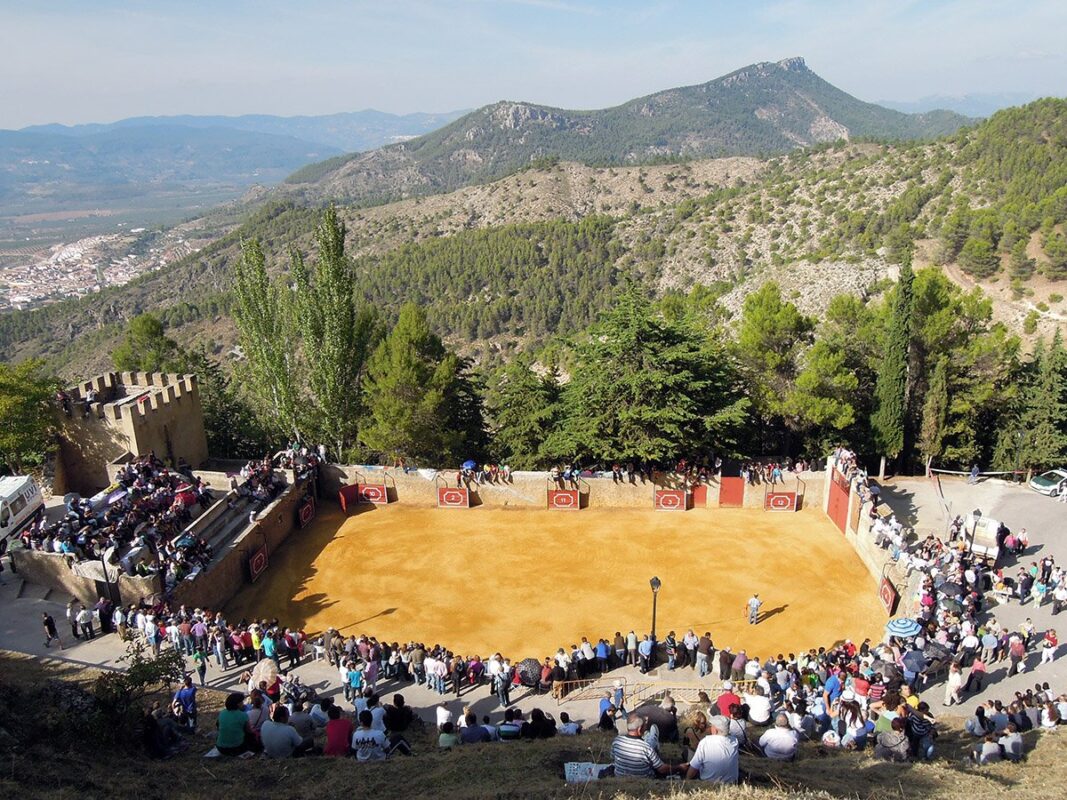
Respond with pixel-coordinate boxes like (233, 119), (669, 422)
(287, 58), (973, 203)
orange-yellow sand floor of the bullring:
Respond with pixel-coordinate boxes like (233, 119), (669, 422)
(226, 505), (886, 659)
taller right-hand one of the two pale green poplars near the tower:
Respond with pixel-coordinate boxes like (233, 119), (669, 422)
(290, 206), (377, 460)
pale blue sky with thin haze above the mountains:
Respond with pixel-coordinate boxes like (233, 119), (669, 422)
(0, 0), (1067, 128)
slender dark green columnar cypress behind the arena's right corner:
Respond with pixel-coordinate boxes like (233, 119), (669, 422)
(871, 263), (914, 459)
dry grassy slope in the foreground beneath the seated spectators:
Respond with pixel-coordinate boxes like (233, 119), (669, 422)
(0, 653), (1067, 800)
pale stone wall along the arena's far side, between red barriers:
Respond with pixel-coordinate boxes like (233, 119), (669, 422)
(322, 464), (824, 509)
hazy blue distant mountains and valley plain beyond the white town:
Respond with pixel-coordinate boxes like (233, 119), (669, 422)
(0, 111), (464, 241)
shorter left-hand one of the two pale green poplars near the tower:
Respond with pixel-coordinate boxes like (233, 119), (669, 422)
(232, 239), (301, 438)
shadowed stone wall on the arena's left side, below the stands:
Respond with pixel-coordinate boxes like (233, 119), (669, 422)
(168, 483), (304, 609)
